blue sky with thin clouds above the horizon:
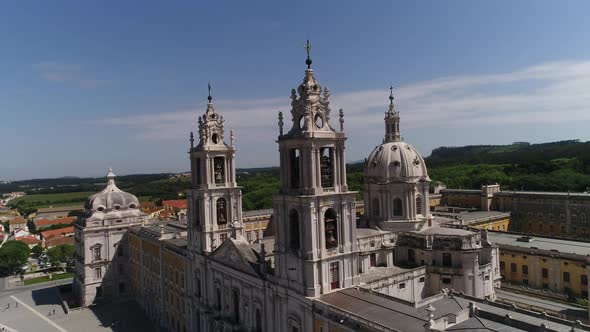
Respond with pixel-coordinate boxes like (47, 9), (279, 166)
(0, 0), (590, 180)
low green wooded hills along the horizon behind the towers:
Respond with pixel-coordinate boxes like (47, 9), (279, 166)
(5, 140), (590, 213)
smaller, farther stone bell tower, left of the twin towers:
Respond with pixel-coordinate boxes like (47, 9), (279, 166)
(187, 85), (243, 253)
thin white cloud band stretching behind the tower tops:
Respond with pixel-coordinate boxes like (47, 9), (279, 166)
(95, 61), (590, 143)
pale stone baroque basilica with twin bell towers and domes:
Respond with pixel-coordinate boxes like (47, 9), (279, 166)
(74, 52), (584, 332)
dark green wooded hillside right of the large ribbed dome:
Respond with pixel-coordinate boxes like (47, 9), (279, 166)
(426, 140), (590, 192)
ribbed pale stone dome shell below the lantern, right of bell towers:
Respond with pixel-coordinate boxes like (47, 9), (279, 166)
(365, 141), (430, 183)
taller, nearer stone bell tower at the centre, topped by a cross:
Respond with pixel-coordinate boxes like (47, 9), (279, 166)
(273, 41), (359, 297)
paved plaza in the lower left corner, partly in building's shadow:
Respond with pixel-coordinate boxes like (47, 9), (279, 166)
(0, 285), (159, 332)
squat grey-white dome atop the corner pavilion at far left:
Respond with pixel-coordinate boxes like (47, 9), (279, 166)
(85, 169), (139, 212)
